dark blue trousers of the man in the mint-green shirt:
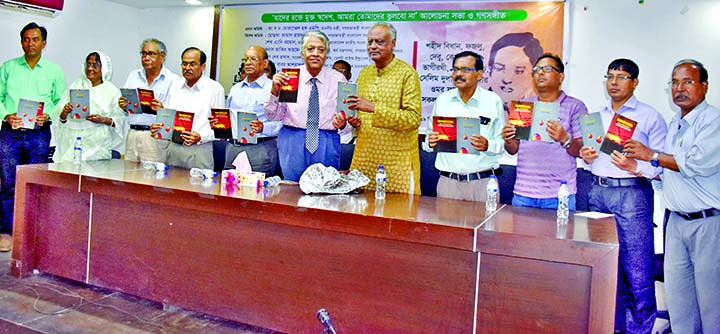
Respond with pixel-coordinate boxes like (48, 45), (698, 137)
(0, 122), (50, 234)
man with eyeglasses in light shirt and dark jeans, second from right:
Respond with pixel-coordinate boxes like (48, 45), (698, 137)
(580, 59), (667, 333)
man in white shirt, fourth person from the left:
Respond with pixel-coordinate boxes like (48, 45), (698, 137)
(150, 47), (225, 169)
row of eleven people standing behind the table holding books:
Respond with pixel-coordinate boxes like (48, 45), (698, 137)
(0, 17), (720, 333)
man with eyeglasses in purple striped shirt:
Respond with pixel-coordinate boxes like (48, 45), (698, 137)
(503, 53), (587, 210)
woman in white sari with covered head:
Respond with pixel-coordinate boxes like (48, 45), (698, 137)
(53, 51), (128, 162)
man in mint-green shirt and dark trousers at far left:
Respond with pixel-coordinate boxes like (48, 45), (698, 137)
(0, 22), (65, 252)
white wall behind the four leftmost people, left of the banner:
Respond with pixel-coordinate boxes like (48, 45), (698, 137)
(0, 0), (214, 87)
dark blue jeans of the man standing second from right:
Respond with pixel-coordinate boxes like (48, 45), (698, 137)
(588, 182), (656, 333)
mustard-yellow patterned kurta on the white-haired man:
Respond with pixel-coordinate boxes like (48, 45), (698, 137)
(351, 58), (422, 194)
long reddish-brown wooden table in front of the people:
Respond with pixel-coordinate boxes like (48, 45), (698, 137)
(11, 160), (618, 333)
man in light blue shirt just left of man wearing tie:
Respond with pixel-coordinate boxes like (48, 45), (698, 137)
(211, 46), (282, 177)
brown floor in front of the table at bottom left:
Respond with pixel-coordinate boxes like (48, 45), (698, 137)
(0, 253), (278, 334)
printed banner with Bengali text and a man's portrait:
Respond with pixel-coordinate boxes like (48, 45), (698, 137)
(218, 1), (565, 132)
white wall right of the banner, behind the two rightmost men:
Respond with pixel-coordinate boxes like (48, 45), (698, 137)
(565, 0), (720, 120)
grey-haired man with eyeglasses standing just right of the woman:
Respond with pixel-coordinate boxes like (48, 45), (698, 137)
(114, 38), (179, 162)
